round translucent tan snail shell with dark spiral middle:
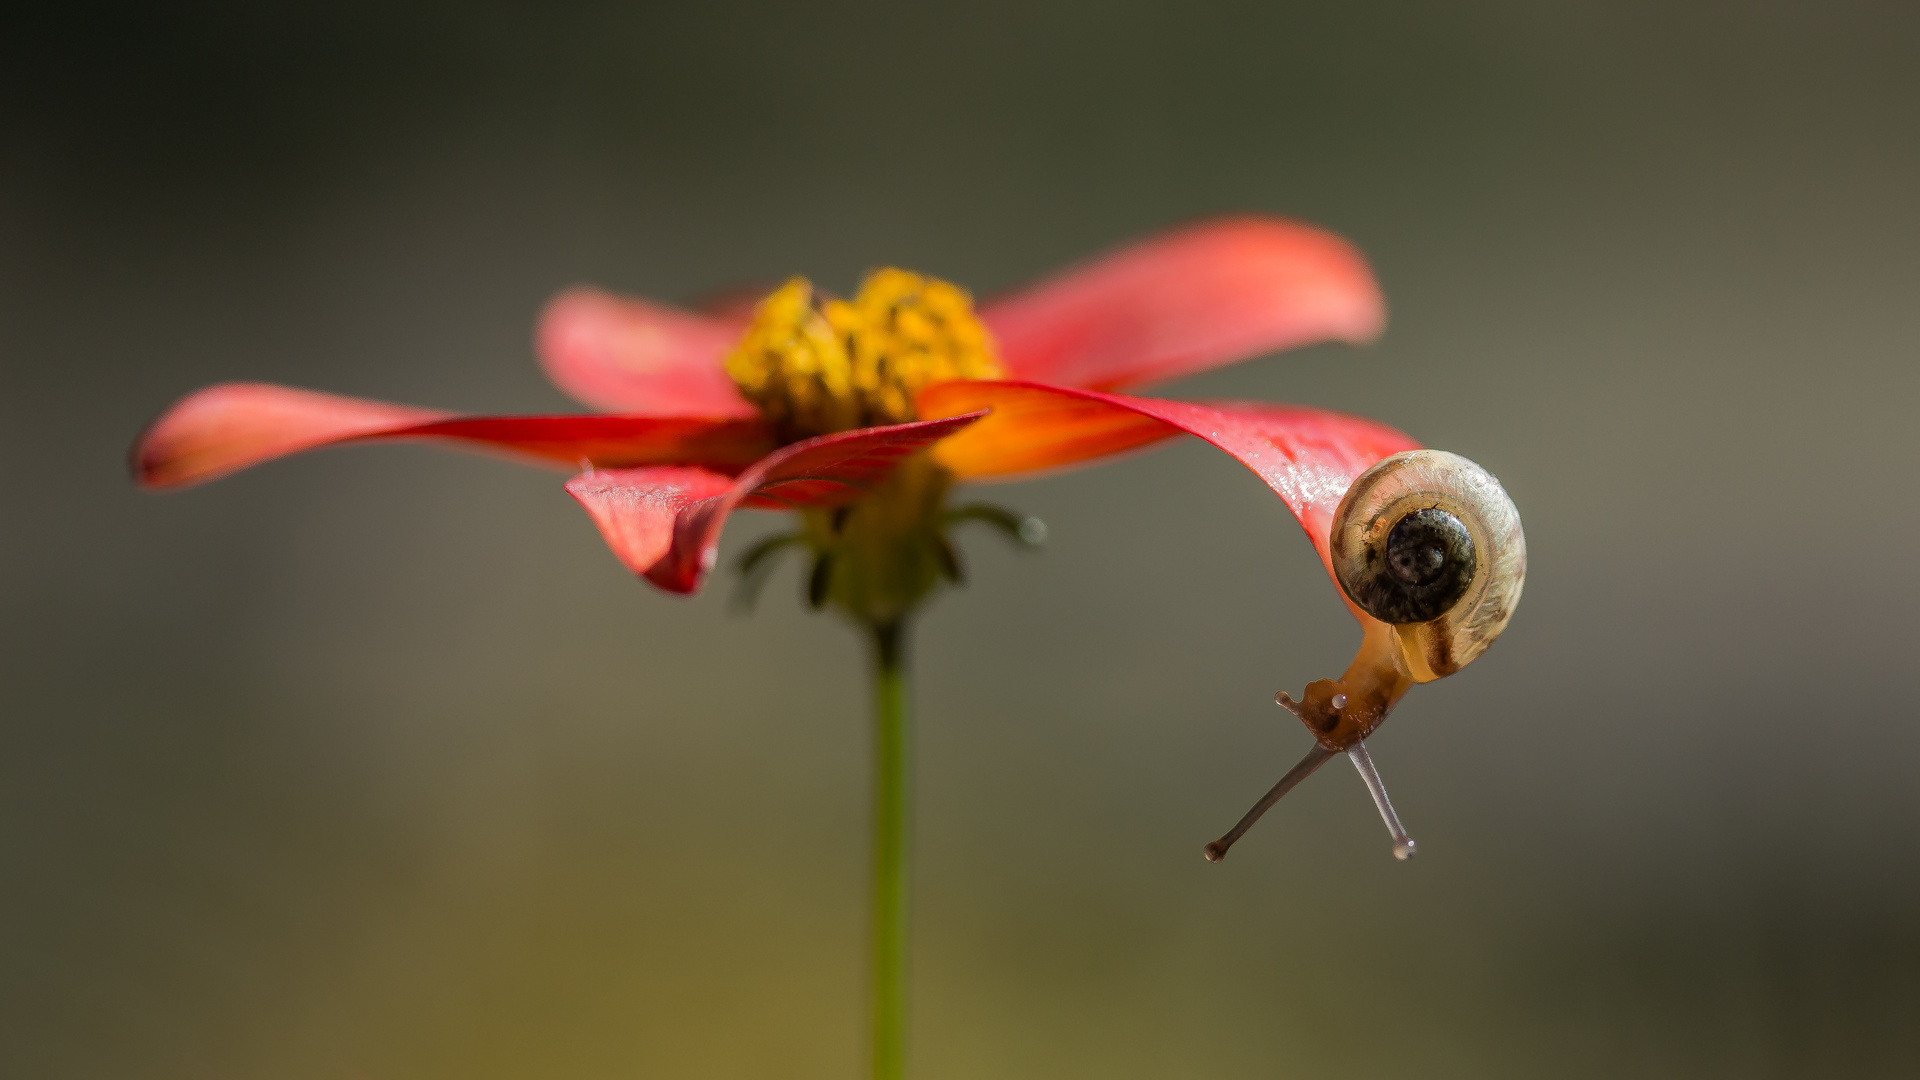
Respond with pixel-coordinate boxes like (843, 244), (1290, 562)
(1331, 450), (1526, 682)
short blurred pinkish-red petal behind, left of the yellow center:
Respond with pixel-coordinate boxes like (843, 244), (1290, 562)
(538, 288), (756, 417)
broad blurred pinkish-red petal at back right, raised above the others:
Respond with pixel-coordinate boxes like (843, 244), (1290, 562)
(981, 217), (1386, 390)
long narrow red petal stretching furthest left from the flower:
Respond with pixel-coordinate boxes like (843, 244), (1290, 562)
(132, 382), (774, 488)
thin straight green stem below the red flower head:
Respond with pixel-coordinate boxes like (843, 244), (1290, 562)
(872, 623), (912, 1080)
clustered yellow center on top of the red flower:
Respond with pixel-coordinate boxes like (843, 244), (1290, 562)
(726, 267), (1002, 440)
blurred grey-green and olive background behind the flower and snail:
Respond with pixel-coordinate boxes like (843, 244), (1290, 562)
(0, 0), (1920, 1080)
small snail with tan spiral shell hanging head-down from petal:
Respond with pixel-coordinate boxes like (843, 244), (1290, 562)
(1206, 450), (1526, 863)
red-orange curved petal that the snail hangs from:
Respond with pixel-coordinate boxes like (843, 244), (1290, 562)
(920, 382), (1419, 575)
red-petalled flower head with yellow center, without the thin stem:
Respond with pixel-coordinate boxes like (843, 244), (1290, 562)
(132, 217), (1417, 625)
